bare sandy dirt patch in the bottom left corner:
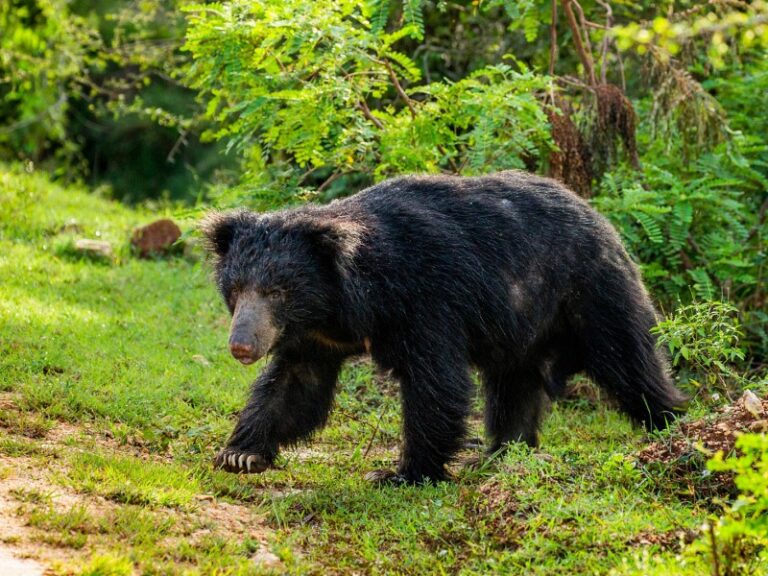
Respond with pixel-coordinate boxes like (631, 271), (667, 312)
(0, 398), (279, 576)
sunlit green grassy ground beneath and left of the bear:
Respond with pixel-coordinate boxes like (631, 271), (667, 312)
(0, 164), (707, 574)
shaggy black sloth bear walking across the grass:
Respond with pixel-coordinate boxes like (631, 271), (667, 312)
(202, 171), (684, 484)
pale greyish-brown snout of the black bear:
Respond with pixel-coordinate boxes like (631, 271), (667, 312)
(229, 292), (277, 365)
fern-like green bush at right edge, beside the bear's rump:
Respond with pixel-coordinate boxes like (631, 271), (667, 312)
(593, 146), (768, 360)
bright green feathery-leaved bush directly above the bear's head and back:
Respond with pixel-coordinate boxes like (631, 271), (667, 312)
(185, 0), (550, 205)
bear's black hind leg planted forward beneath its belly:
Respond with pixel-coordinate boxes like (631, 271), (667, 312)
(483, 365), (546, 454)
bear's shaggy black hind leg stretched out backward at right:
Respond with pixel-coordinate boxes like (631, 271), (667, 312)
(582, 279), (688, 430)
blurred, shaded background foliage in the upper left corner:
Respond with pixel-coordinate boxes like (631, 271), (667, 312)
(0, 0), (231, 202)
